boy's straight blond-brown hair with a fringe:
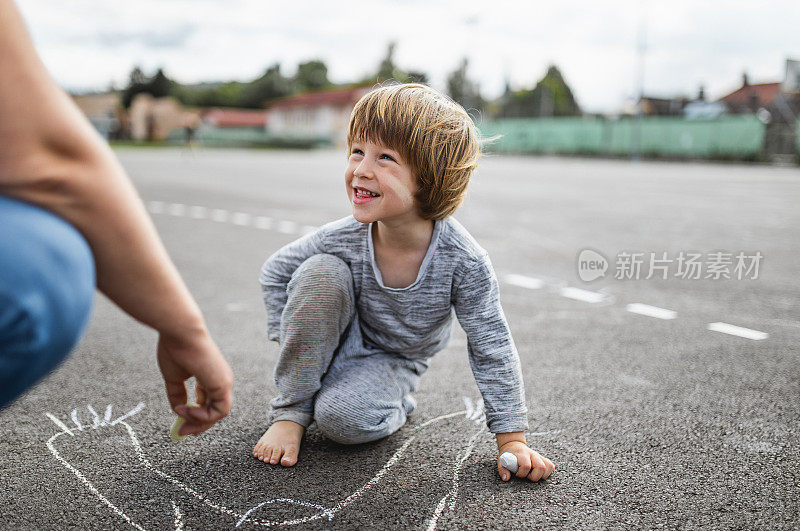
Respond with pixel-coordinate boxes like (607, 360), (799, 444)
(347, 83), (481, 220)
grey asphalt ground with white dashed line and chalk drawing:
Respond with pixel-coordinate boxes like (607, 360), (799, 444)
(0, 148), (800, 530)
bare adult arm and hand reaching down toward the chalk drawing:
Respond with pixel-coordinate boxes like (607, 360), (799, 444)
(0, 0), (233, 434)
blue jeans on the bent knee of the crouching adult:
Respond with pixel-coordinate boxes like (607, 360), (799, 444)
(0, 195), (95, 408)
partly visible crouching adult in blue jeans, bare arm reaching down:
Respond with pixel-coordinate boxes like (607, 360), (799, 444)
(0, 0), (233, 435)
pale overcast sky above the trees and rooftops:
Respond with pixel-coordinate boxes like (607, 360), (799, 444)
(18, 0), (800, 112)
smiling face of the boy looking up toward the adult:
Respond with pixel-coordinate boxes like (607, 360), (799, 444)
(345, 140), (422, 223)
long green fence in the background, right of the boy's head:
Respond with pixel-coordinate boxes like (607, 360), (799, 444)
(480, 115), (764, 158)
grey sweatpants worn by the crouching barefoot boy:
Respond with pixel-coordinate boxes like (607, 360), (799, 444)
(269, 254), (427, 444)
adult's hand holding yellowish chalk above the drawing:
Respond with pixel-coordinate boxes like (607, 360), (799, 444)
(158, 329), (233, 435)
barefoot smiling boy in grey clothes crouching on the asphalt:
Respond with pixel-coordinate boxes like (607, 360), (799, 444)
(253, 84), (554, 481)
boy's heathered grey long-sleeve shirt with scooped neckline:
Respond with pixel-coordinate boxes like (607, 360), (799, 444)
(259, 216), (528, 433)
